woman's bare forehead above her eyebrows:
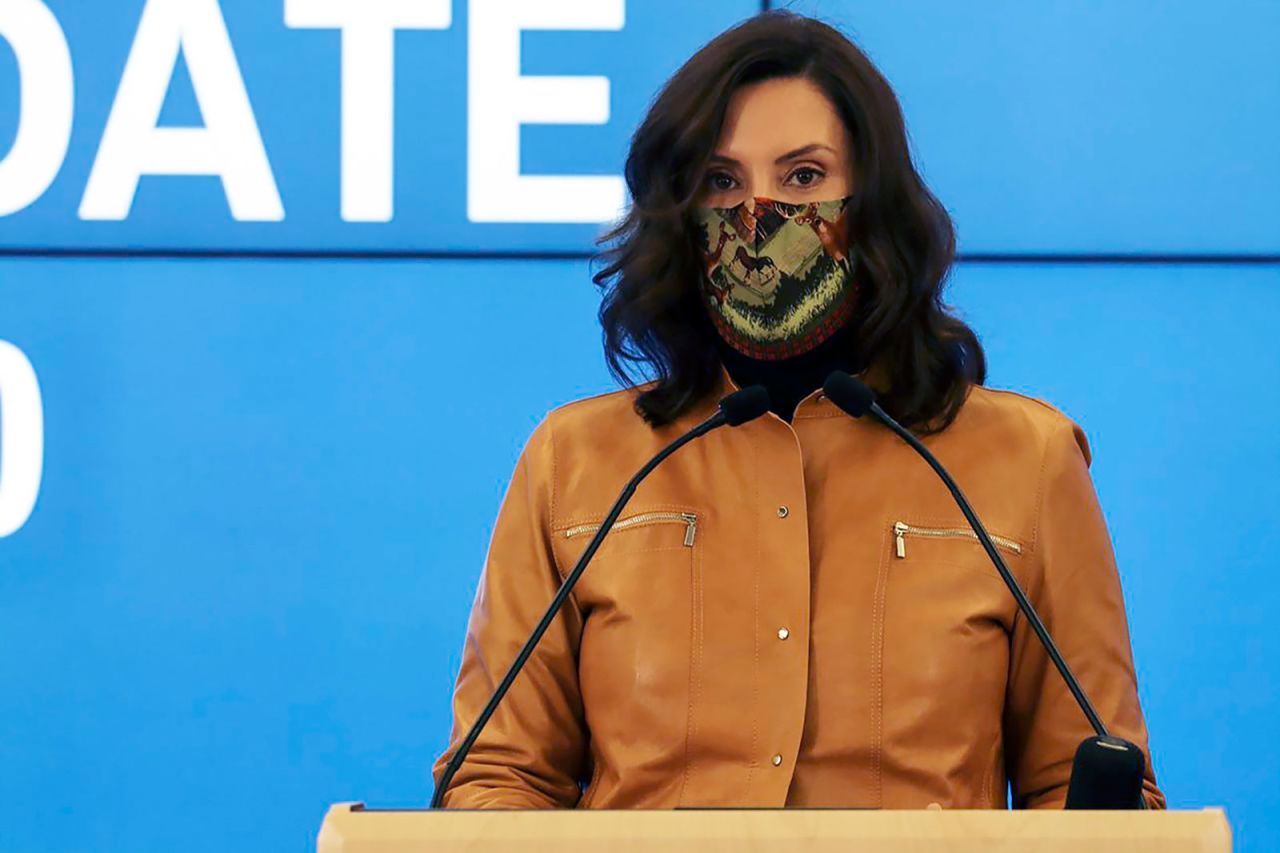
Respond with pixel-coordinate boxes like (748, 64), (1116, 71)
(716, 77), (847, 160)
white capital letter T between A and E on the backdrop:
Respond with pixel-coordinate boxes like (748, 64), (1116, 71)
(284, 0), (453, 222)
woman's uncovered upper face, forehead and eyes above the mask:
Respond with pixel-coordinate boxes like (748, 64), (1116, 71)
(698, 77), (852, 207)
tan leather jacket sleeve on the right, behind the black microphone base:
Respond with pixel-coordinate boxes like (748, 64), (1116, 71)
(1005, 419), (1165, 808)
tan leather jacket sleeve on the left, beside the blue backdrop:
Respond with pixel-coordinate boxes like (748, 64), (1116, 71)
(433, 421), (586, 808)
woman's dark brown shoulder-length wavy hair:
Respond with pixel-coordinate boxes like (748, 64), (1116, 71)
(593, 10), (987, 434)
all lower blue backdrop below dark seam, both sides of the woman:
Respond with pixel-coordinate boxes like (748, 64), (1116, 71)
(0, 260), (1280, 853)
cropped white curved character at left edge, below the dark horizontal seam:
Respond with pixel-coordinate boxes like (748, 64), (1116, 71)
(0, 341), (45, 537)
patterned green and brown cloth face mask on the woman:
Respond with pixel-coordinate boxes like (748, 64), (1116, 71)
(694, 196), (855, 360)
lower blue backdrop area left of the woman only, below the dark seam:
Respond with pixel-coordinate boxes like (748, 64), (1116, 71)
(0, 261), (609, 853)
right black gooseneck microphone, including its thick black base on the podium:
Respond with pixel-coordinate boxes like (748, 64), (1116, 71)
(822, 370), (1147, 809)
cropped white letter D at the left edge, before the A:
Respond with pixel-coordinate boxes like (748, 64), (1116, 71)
(0, 0), (76, 216)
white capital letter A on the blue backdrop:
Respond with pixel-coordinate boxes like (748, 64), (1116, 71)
(79, 0), (284, 222)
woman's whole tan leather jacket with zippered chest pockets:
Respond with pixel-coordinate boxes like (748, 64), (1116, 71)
(434, 374), (1164, 808)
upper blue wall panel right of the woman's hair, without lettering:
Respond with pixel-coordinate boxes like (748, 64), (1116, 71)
(774, 0), (1280, 255)
